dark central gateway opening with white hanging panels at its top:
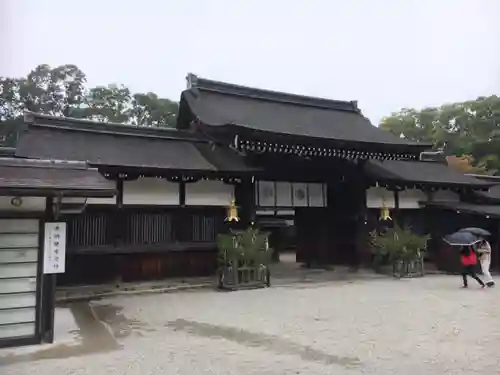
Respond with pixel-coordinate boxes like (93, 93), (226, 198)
(255, 158), (366, 267)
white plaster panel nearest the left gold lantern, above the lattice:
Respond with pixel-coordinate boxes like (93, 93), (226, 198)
(186, 180), (234, 207)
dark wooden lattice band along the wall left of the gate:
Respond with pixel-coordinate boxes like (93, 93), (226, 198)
(64, 207), (225, 253)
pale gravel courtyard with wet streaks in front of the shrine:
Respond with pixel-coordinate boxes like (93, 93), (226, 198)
(0, 276), (500, 375)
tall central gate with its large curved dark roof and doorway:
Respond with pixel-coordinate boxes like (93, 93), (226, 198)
(177, 74), (429, 266)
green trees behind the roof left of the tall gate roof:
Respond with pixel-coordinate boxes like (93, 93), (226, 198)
(0, 64), (178, 146)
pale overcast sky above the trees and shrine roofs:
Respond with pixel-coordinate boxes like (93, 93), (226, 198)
(0, 0), (500, 123)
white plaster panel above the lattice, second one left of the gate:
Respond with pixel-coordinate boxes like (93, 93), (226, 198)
(123, 177), (179, 206)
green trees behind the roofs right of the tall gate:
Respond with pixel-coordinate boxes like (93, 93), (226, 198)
(380, 95), (500, 174)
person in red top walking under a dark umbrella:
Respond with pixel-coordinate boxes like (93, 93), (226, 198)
(444, 231), (486, 288)
